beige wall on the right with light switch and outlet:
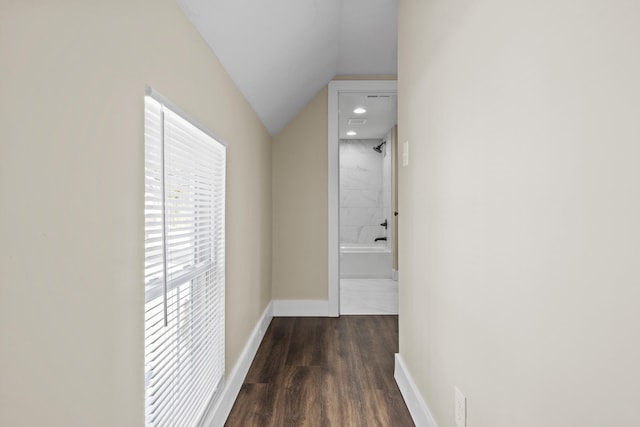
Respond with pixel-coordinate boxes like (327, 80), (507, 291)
(398, 0), (640, 427)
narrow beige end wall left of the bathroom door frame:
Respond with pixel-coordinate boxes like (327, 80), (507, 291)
(272, 88), (328, 300)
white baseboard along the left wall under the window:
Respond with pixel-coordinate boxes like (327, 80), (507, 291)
(199, 301), (273, 427)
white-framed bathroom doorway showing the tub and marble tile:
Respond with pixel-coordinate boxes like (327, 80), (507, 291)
(328, 80), (398, 315)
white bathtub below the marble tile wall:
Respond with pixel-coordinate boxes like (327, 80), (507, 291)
(340, 243), (392, 279)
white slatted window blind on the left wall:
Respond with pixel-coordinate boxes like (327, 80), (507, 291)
(144, 95), (226, 427)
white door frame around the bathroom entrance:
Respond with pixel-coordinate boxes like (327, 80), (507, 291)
(327, 80), (398, 317)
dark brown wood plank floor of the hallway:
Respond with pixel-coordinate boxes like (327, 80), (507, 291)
(226, 316), (414, 427)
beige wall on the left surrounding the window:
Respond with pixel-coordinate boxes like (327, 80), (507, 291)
(0, 0), (271, 427)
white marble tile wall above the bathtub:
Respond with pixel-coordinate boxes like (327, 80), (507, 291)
(340, 139), (386, 244)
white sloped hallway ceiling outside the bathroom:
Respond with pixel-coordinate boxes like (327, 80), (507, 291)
(178, 0), (398, 135)
